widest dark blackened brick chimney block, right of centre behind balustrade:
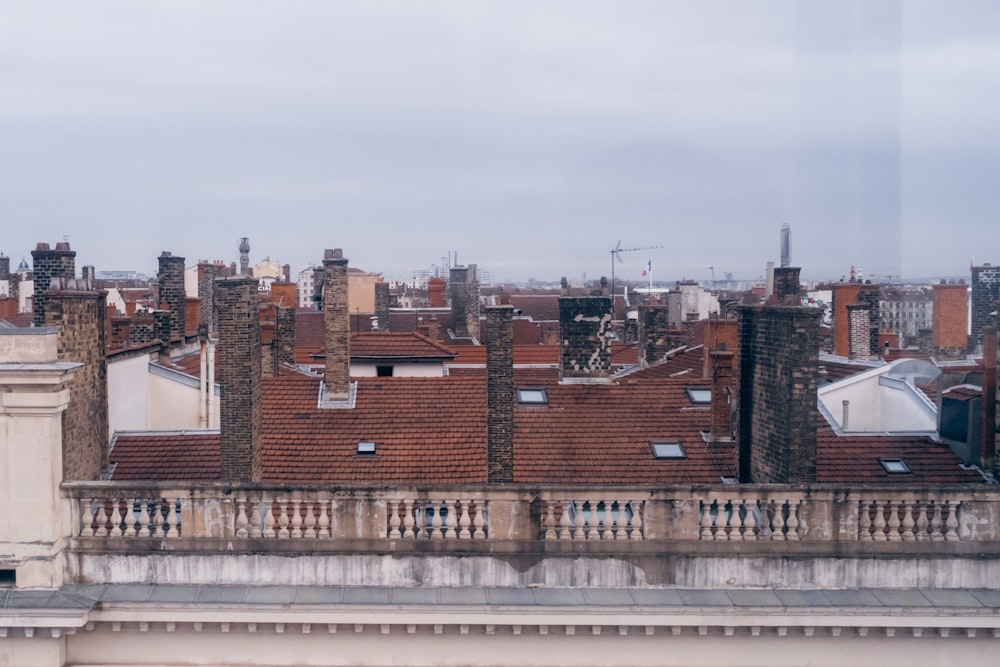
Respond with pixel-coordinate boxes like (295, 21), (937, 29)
(735, 306), (821, 484)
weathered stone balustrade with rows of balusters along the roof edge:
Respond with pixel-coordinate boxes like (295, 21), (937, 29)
(63, 482), (1000, 550)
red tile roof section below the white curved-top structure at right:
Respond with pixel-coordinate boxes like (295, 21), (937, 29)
(816, 426), (983, 484)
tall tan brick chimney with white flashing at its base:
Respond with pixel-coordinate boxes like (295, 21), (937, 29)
(323, 248), (351, 401)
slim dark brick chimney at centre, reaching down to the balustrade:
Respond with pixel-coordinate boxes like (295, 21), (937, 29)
(486, 306), (514, 484)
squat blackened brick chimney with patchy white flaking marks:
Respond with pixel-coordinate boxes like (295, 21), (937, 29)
(559, 296), (611, 381)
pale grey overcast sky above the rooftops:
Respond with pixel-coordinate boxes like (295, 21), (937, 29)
(0, 0), (1000, 280)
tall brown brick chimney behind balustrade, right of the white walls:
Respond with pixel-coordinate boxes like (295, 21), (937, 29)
(215, 276), (263, 483)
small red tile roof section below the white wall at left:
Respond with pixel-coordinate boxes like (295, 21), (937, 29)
(109, 431), (219, 481)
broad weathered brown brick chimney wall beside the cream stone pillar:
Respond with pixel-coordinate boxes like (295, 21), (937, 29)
(43, 278), (108, 481)
